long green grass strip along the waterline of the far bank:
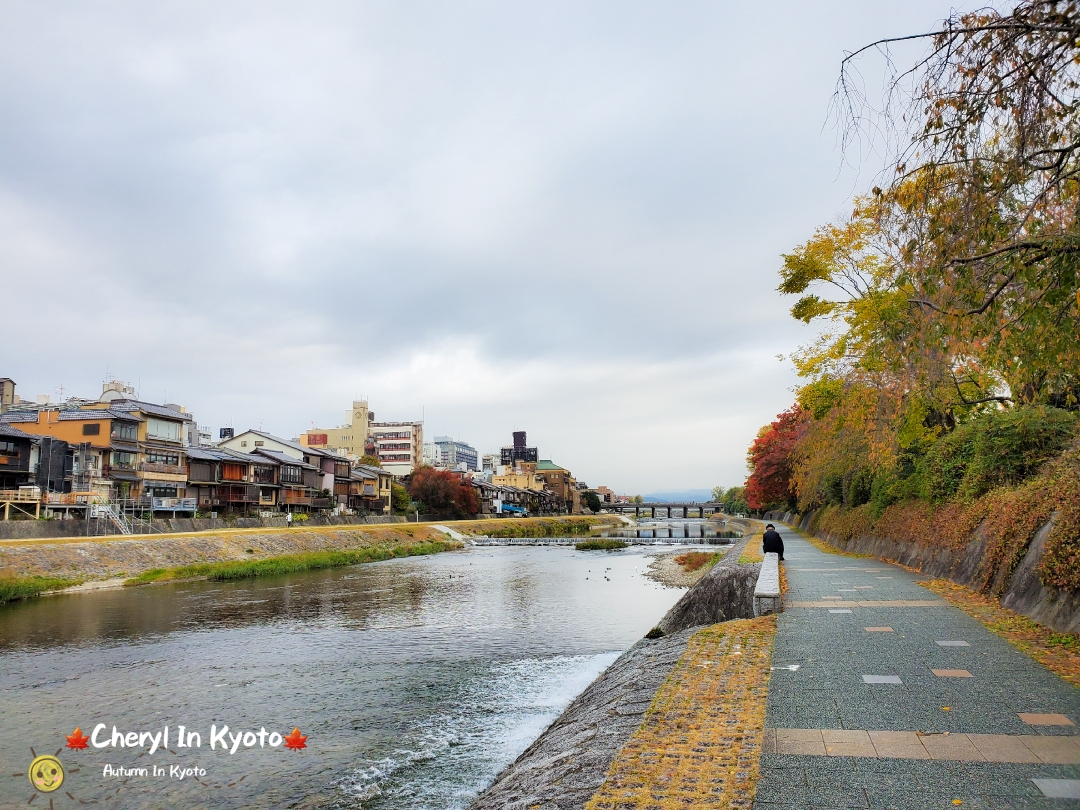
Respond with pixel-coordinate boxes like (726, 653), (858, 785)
(124, 540), (461, 585)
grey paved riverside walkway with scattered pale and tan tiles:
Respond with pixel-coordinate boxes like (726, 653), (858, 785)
(754, 530), (1080, 810)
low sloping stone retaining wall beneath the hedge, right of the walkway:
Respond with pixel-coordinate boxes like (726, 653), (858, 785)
(766, 512), (1080, 633)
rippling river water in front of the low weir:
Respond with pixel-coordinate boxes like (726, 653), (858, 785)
(0, 546), (681, 810)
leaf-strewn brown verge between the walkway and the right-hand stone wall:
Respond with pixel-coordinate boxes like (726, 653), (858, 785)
(919, 579), (1080, 687)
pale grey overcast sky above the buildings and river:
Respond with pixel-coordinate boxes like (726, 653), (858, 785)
(0, 0), (963, 494)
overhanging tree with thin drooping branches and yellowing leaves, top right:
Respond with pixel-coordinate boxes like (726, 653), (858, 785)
(836, 0), (1080, 408)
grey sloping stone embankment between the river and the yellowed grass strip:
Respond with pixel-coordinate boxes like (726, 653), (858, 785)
(472, 525), (760, 810)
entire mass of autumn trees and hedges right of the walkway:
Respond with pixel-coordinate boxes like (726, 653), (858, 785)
(745, 2), (1080, 590)
